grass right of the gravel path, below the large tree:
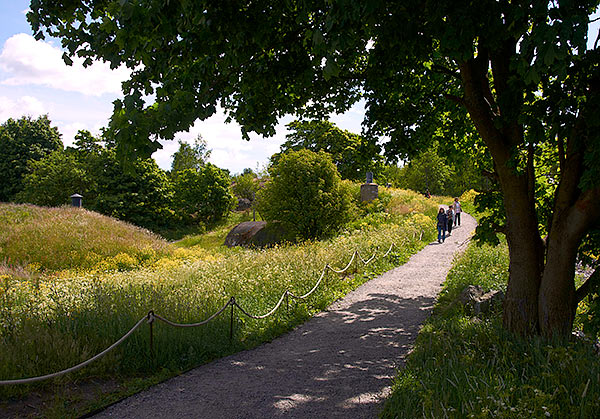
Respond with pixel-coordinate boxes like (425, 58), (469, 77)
(382, 241), (600, 418)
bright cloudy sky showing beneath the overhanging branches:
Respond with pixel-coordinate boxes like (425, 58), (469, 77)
(0, 0), (364, 174)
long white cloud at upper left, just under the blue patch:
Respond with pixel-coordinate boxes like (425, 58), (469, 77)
(0, 33), (130, 96)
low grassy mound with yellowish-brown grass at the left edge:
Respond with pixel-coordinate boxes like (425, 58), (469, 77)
(0, 204), (171, 274)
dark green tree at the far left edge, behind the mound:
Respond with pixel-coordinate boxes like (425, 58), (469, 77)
(0, 115), (63, 201)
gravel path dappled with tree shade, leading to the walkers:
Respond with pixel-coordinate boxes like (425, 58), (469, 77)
(95, 213), (476, 419)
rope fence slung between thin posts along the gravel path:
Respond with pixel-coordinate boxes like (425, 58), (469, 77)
(0, 243), (394, 386)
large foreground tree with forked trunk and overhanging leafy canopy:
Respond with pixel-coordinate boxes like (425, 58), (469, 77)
(28, 0), (600, 337)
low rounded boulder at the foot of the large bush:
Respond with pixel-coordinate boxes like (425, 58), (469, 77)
(225, 221), (288, 248)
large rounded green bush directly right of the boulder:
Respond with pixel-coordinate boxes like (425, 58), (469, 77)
(256, 149), (350, 239)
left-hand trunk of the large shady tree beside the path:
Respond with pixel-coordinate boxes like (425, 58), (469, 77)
(460, 55), (544, 335)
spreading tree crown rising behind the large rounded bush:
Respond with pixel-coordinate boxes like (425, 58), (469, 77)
(271, 121), (383, 181)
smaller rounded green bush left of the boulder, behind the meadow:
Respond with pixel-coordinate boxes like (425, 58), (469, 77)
(173, 163), (236, 223)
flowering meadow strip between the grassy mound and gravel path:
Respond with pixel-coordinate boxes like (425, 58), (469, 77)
(0, 191), (436, 413)
